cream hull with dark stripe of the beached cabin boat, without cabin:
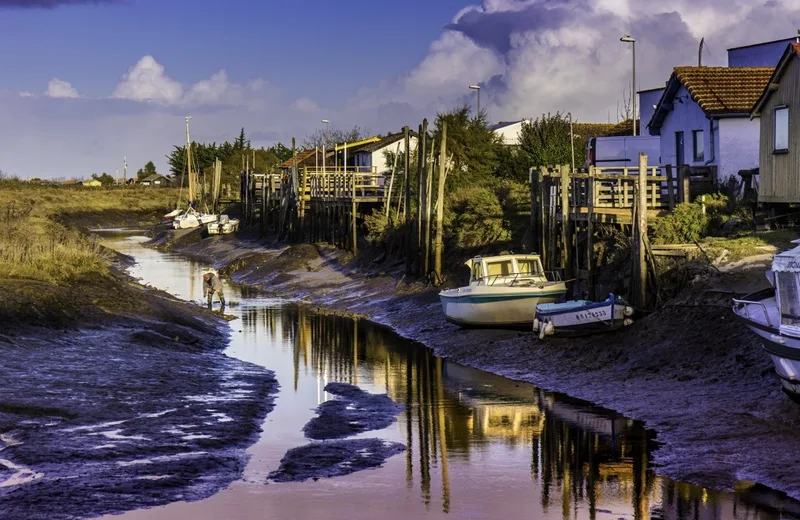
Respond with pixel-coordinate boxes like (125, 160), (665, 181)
(439, 284), (567, 328)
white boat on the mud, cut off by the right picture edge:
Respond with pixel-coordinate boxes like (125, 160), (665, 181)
(733, 240), (800, 401)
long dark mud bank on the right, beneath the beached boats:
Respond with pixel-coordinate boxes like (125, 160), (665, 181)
(152, 226), (800, 498)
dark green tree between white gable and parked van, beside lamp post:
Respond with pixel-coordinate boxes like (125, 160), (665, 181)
(519, 112), (586, 166)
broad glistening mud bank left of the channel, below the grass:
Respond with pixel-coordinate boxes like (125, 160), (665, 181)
(0, 257), (277, 519)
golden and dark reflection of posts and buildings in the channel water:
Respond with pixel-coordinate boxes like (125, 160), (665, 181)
(241, 305), (798, 520)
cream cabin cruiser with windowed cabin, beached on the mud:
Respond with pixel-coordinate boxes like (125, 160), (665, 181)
(439, 254), (567, 328)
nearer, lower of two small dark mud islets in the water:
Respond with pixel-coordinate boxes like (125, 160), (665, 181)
(269, 439), (406, 482)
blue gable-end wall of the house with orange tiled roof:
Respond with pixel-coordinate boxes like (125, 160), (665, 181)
(661, 87), (719, 166)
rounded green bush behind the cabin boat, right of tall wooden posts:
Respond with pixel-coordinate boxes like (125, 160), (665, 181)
(445, 186), (510, 249)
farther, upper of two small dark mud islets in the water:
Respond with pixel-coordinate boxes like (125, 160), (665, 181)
(303, 383), (403, 440)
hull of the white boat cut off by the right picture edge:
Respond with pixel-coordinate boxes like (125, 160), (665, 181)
(733, 290), (800, 403)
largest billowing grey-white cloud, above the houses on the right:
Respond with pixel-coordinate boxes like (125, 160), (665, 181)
(349, 0), (800, 124)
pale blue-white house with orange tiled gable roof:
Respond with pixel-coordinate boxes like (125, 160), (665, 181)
(646, 66), (775, 181)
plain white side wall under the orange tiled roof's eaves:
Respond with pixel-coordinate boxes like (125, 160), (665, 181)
(714, 117), (761, 182)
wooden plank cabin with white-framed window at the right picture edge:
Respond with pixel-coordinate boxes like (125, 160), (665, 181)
(750, 43), (800, 204)
